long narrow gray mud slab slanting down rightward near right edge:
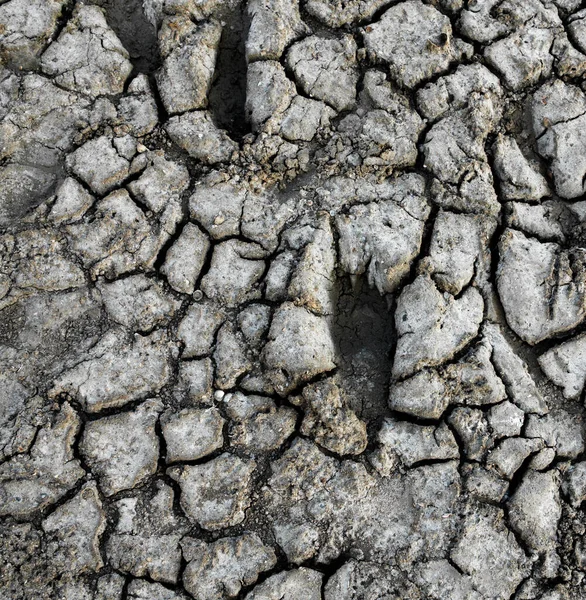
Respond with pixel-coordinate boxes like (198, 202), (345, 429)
(482, 323), (548, 415)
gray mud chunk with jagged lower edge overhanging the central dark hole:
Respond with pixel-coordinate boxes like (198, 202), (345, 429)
(335, 174), (430, 294)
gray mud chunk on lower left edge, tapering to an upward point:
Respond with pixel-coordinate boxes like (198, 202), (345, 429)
(0, 402), (85, 517)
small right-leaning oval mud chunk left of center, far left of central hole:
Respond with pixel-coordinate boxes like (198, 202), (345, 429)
(161, 223), (210, 294)
